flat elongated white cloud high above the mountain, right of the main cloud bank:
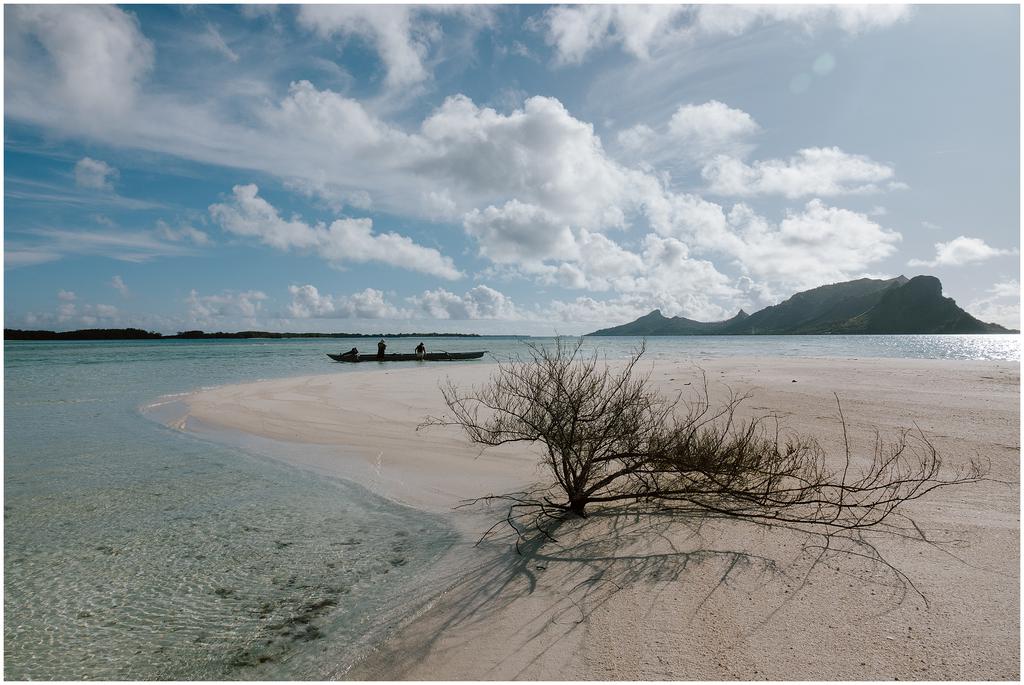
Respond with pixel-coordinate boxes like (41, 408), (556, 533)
(701, 147), (905, 199)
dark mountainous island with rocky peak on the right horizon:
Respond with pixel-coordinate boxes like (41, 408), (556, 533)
(590, 275), (1017, 336)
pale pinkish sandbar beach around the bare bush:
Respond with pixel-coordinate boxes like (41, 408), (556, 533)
(161, 358), (1020, 680)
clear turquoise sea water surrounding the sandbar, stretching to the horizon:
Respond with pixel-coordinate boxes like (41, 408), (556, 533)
(4, 336), (1020, 680)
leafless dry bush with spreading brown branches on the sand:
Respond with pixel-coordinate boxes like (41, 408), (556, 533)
(425, 340), (984, 531)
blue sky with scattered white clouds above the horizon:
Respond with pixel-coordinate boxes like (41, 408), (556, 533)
(3, 4), (1020, 335)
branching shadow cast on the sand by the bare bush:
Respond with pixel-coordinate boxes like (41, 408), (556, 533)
(345, 503), (970, 680)
